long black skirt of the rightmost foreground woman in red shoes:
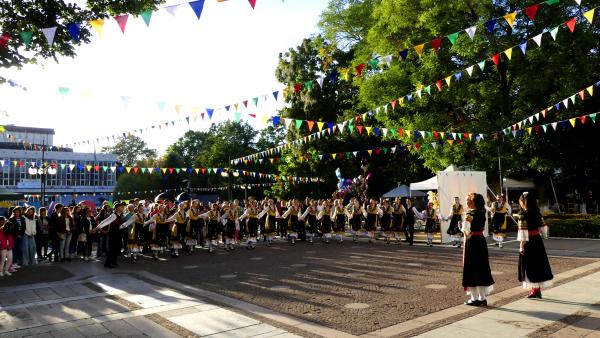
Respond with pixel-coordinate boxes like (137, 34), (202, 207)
(519, 235), (554, 283)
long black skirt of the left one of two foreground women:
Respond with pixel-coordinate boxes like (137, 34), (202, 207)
(463, 236), (494, 288)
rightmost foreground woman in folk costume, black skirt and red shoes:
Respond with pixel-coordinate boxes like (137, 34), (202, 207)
(517, 193), (554, 298)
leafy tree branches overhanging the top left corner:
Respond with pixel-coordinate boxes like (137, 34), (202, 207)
(0, 0), (164, 81)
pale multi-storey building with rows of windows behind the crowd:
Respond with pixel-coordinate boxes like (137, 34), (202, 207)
(0, 125), (117, 204)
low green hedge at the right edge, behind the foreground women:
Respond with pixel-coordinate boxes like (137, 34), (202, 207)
(544, 215), (600, 238)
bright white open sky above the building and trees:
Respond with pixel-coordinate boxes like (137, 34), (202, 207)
(0, 0), (327, 153)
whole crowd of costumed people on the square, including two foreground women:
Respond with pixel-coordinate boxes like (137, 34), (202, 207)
(0, 193), (552, 306)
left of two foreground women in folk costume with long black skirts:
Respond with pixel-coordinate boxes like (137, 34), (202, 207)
(461, 193), (494, 306)
